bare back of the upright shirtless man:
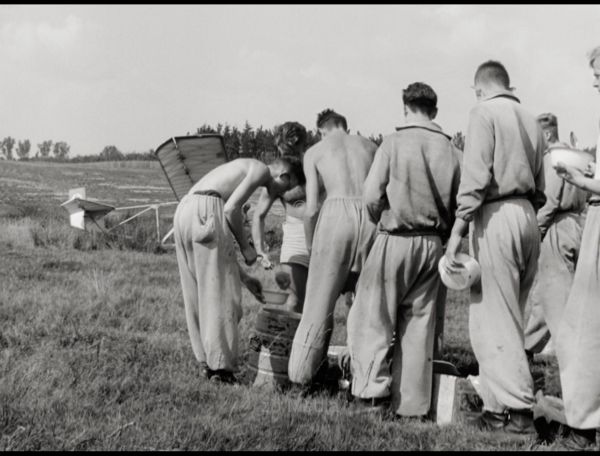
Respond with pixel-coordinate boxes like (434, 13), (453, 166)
(307, 131), (377, 198)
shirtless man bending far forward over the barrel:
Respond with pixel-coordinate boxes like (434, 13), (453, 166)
(173, 158), (301, 382)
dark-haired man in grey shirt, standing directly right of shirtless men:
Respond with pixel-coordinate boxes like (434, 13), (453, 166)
(348, 82), (460, 417)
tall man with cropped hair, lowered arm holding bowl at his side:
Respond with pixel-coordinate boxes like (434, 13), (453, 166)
(446, 61), (546, 433)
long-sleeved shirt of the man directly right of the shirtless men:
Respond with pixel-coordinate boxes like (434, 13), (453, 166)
(363, 121), (461, 237)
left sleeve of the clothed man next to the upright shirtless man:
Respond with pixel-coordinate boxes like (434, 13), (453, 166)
(363, 141), (390, 223)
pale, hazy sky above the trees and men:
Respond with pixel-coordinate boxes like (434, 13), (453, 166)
(0, 4), (600, 156)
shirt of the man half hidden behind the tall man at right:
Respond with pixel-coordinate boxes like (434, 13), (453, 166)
(537, 143), (587, 235)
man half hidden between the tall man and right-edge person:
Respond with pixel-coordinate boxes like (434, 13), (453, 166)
(525, 113), (587, 357)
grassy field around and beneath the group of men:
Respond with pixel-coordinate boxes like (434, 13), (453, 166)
(0, 162), (558, 450)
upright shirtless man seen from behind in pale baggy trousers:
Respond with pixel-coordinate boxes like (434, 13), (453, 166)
(288, 109), (377, 384)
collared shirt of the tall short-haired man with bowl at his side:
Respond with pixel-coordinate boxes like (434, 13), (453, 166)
(456, 90), (546, 222)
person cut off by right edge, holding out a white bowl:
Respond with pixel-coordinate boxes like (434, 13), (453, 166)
(556, 46), (600, 449)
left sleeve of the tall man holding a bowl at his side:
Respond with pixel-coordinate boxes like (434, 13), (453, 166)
(456, 106), (494, 222)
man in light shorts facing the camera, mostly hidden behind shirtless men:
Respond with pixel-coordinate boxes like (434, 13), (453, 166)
(252, 122), (308, 312)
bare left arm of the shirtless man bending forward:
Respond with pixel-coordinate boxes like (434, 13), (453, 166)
(223, 165), (269, 264)
